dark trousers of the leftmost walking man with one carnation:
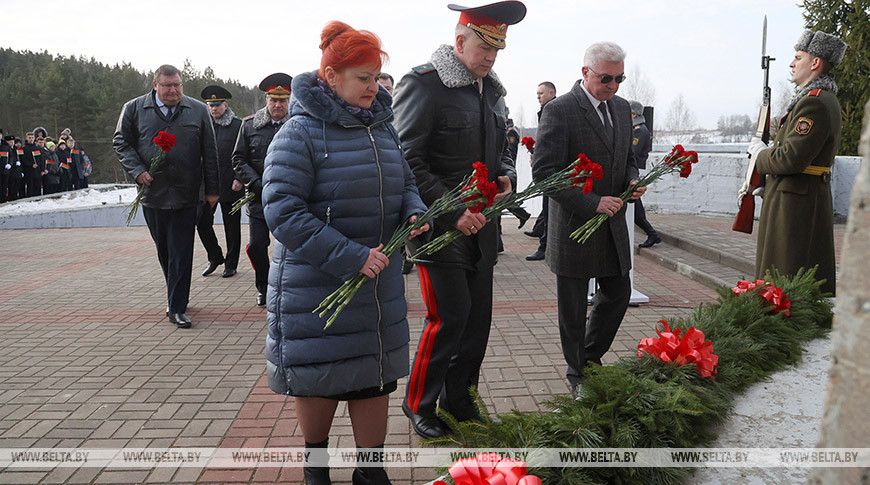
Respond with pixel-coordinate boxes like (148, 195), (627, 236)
(142, 206), (196, 313)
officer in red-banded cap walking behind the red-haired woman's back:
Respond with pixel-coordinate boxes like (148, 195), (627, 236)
(233, 72), (293, 306)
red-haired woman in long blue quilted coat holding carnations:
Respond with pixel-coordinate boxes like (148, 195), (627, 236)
(263, 22), (428, 484)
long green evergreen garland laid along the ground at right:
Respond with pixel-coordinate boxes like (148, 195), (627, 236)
(423, 268), (833, 484)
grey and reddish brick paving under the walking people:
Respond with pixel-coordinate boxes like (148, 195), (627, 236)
(0, 220), (716, 484)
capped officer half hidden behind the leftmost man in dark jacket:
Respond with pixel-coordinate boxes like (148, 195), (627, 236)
(196, 85), (244, 278)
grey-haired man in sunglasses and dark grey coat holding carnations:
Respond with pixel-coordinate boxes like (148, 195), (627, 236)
(532, 42), (645, 391)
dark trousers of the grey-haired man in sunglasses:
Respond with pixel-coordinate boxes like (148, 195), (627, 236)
(556, 273), (631, 386)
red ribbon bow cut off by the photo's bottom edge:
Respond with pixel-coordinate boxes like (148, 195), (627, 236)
(434, 453), (541, 485)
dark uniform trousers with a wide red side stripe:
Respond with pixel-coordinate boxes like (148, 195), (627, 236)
(405, 264), (492, 420)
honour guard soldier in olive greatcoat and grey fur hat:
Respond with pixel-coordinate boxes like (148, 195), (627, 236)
(748, 30), (846, 293)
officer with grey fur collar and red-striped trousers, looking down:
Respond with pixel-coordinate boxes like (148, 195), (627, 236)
(394, 1), (526, 438)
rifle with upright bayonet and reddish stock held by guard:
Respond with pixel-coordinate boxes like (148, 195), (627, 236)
(731, 15), (776, 234)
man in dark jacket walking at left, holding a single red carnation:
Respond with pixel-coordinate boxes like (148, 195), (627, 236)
(113, 64), (218, 328)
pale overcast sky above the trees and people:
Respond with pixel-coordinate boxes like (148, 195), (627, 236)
(0, 0), (803, 128)
